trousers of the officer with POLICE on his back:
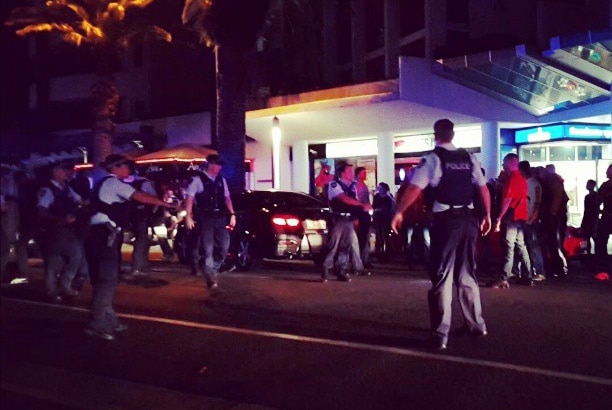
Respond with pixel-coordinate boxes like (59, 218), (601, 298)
(428, 211), (486, 342)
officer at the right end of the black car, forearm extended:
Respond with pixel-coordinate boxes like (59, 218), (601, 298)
(321, 161), (372, 282)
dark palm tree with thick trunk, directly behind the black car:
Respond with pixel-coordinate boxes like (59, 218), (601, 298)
(183, 0), (270, 191)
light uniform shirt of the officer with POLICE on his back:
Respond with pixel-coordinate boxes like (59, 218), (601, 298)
(410, 142), (487, 212)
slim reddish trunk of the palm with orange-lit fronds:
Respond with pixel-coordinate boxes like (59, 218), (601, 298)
(91, 77), (119, 166)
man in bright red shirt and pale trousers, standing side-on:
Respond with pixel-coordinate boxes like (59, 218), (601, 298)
(491, 154), (533, 288)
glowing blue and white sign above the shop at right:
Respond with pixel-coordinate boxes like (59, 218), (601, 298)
(514, 125), (612, 144)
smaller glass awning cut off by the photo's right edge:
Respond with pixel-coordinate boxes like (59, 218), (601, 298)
(544, 29), (612, 89)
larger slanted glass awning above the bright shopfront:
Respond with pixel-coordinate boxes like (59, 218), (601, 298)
(434, 46), (610, 116)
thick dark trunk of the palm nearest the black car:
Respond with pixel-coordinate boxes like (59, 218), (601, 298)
(215, 45), (247, 192)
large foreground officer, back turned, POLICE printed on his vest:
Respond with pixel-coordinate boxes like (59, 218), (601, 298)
(391, 119), (491, 350)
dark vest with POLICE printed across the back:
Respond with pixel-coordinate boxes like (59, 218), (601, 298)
(433, 147), (474, 206)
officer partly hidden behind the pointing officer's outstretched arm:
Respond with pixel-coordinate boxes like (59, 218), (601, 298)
(123, 161), (157, 275)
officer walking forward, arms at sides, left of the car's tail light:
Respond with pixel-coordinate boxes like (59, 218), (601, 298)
(185, 154), (236, 289)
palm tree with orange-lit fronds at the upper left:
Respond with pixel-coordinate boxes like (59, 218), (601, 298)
(6, 0), (172, 165)
